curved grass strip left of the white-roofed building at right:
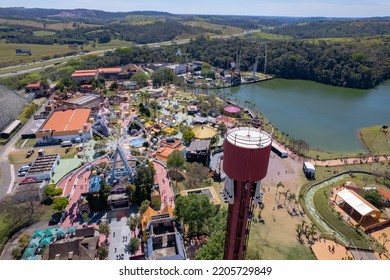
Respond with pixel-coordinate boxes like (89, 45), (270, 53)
(314, 186), (369, 249)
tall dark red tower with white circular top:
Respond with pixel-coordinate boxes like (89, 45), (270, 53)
(223, 127), (272, 260)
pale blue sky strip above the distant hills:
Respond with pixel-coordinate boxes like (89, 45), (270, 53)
(0, 0), (390, 17)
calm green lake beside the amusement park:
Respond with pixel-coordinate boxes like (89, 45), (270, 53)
(230, 79), (390, 153)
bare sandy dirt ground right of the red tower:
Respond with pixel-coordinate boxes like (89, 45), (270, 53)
(247, 153), (314, 260)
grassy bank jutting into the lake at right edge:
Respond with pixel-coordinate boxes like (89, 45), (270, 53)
(359, 125), (390, 155)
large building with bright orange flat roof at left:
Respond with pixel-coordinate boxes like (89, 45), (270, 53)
(35, 109), (92, 143)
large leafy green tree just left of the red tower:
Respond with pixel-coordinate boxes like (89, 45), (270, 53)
(175, 194), (215, 235)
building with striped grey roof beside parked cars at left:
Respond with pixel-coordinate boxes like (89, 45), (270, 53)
(25, 154), (60, 181)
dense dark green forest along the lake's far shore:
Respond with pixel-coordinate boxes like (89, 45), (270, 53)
(74, 37), (390, 89)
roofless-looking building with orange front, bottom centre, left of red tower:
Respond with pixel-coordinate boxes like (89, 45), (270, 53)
(142, 205), (187, 260)
